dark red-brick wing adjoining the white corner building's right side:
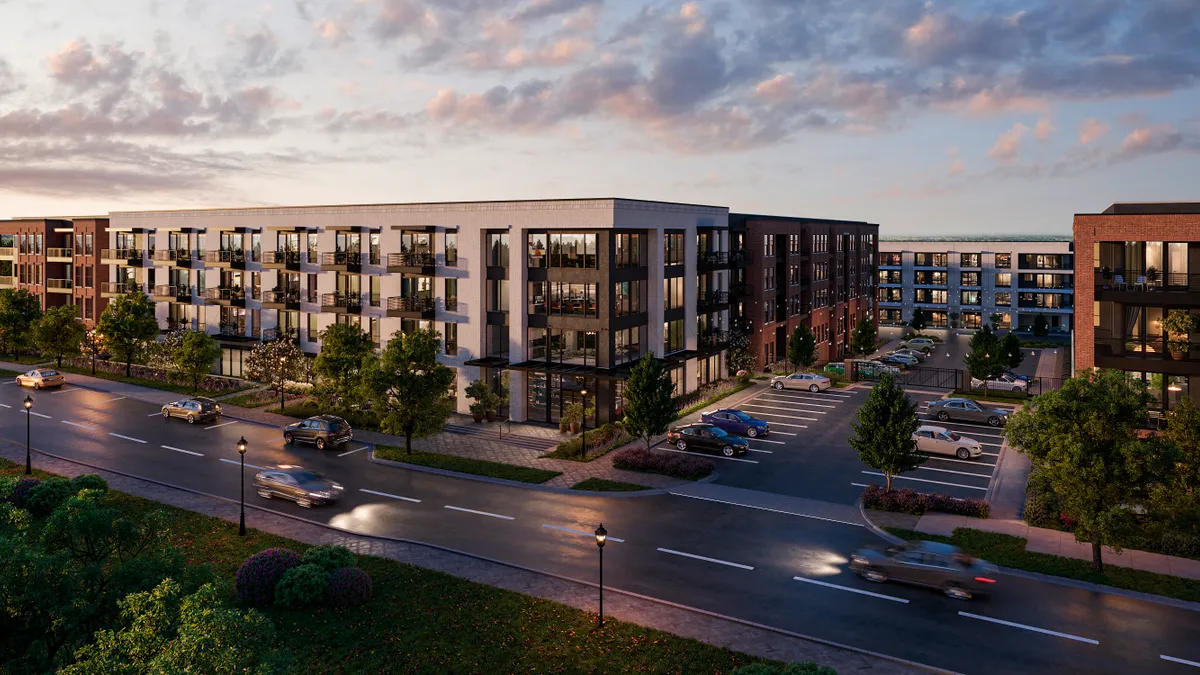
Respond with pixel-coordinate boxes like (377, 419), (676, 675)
(730, 214), (880, 369)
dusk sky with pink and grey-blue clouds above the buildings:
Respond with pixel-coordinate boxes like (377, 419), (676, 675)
(0, 0), (1200, 235)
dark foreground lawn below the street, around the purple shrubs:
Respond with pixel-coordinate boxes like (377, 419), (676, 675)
(0, 460), (761, 674)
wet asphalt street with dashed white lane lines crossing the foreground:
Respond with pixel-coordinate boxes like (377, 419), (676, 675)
(0, 383), (1200, 675)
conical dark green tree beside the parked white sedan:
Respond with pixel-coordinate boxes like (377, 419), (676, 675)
(850, 375), (925, 490)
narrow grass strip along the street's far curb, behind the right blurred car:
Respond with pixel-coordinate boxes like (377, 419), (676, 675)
(887, 527), (1200, 602)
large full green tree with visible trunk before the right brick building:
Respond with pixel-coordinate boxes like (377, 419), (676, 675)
(1004, 370), (1163, 571)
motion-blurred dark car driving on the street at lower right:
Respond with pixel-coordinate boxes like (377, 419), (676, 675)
(850, 542), (998, 601)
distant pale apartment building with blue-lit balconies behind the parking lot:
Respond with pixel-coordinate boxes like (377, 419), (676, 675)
(876, 238), (1075, 333)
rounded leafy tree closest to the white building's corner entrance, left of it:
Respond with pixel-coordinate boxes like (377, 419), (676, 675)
(362, 329), (453, 454)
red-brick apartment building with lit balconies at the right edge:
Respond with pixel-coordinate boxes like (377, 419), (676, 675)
(1074, 202), (1200, 413)
